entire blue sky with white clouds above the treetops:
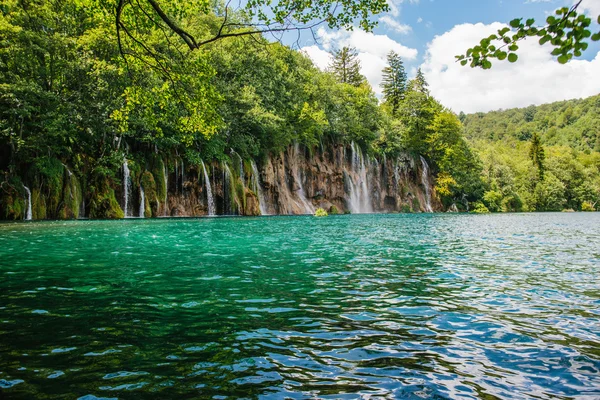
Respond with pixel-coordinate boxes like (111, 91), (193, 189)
(302, 0), (600, 113)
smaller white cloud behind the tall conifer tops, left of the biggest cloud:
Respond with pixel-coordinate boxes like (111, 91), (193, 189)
(301, 27), (418, 94)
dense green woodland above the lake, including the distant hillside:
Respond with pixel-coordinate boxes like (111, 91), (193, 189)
(0, 0), (600, 219)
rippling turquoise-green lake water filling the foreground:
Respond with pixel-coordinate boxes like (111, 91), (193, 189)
(0, 214), (600, 399)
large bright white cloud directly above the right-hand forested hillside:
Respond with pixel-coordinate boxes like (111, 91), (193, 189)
(422, 23), (600, 112)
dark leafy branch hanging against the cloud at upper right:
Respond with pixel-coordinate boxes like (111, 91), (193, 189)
(456, 0), (600, 69)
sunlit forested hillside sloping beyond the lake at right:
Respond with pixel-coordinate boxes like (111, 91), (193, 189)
(460, 95), (600, 211)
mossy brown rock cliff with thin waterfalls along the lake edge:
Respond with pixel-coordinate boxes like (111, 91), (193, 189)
(0, 144), (442, 219)
